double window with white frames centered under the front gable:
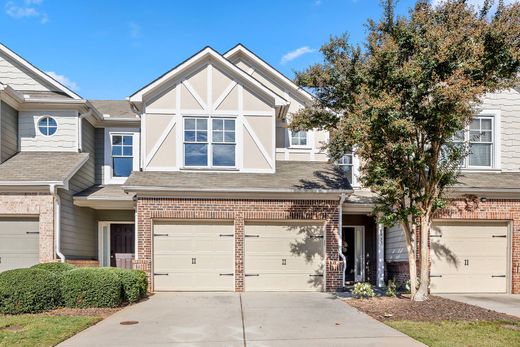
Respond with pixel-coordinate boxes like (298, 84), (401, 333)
(184, 117), (236, 168)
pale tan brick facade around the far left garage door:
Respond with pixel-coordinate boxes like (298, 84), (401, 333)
(0, 193), (55, 262)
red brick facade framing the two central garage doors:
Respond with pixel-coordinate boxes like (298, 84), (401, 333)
(134, 197), (343, 292)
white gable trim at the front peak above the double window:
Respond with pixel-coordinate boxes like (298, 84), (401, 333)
(129, 46), (288, 106)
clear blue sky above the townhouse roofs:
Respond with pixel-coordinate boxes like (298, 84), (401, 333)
(0, 0), (494, 99)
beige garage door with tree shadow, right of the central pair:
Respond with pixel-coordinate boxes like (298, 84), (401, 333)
(244, 223), (324, 291)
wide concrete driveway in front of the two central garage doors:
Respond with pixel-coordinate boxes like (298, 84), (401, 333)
(60, 293), (423, 347)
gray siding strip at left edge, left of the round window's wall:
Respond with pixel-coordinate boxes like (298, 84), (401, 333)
(0, 101), (18, 163)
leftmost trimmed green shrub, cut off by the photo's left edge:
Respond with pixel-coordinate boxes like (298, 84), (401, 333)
(0, 269), (61, 314)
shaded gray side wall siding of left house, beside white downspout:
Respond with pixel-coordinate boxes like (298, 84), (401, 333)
(60, 119), (98, 259)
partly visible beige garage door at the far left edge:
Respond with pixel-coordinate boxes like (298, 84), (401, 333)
(0, 218), (39, 272)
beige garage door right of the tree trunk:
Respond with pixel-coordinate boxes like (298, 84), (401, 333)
(430, 222), (508, 293)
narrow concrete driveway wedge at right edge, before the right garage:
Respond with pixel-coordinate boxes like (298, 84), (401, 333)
(441, 294), (520, 317)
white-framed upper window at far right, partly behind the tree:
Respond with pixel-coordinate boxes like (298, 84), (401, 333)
(454, 116), (497, 169)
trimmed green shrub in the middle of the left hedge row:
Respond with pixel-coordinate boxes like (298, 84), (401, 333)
(61, 268), (123, 308)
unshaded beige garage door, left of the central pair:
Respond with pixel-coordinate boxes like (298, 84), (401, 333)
(153, 222), (235, 291)
